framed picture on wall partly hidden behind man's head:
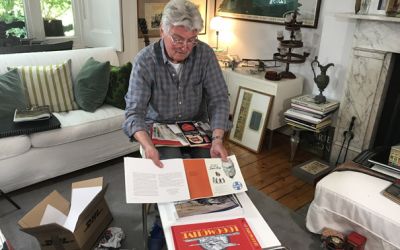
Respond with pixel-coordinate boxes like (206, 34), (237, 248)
(137, 0), (207, 38)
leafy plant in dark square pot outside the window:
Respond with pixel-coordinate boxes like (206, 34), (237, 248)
(41, 0), (72, 36)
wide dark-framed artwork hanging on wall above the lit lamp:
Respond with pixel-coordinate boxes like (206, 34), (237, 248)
(214, 0), (321, 28)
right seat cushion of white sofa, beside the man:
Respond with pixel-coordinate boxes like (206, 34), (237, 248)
(30, 105), (125, 147)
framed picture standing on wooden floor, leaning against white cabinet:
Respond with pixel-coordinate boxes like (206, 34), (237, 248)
(229, 86), (273, 153)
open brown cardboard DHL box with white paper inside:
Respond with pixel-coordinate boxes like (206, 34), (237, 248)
(18, 177), (112, 250)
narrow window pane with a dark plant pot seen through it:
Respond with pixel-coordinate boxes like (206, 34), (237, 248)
(40, 0), (75, 37)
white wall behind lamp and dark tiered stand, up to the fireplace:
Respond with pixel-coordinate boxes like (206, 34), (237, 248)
(208, 0), (355, 100)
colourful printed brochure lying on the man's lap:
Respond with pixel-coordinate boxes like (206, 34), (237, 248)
(151, 121), (212, 147)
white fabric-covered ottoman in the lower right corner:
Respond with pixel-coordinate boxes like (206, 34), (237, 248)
(306, 171), (400, 250)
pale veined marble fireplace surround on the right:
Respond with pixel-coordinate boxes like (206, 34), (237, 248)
(330, 14), (400, 163)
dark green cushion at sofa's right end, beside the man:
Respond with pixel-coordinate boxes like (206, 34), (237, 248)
(105, 62), (132, 109)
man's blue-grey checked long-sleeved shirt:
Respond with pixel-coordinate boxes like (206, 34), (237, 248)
(123, 40), (231, 137)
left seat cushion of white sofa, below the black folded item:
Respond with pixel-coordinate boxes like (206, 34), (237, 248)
(0, 135), (31, 160)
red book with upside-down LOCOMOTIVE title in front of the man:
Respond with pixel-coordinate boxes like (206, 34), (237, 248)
(171, 218), (261, 250)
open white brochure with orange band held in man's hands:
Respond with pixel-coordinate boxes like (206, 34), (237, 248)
(124, 155), (247, 203)
